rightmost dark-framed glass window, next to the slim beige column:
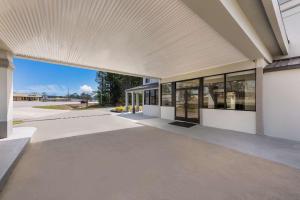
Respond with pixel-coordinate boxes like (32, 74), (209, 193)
(226, 70), (255, 111)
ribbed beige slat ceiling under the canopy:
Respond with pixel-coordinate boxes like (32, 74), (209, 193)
(0, 0), (247, 78)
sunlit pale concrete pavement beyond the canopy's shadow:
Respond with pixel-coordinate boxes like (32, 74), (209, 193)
(16, 108), (141, 142)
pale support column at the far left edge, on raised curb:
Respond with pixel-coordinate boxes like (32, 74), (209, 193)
(0, 50), (13, 139)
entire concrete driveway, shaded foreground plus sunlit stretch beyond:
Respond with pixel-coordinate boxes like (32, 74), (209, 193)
(0, 109), (300, 200)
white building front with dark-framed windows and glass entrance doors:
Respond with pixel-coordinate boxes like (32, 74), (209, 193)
(126, 0), (300, 140)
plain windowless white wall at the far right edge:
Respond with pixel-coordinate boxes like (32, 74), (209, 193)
(263, 69), (300, 141)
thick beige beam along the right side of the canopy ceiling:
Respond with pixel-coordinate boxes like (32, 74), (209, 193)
(182, 0), (272, 62)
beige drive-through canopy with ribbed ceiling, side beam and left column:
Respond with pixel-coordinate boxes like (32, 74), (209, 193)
(0, 0), (287, 138)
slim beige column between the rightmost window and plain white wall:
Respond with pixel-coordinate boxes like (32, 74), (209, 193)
(255, 59), (267, 135)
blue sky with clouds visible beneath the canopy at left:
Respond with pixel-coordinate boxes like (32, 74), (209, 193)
(14, 58), (97, 95)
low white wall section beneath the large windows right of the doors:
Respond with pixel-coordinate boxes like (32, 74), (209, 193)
(200, 109), (256, 134)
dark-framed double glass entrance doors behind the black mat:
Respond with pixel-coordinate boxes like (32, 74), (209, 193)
(175, 88), (199, 123)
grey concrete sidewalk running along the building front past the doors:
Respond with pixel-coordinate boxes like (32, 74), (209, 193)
(119, 114), (300, 169)
